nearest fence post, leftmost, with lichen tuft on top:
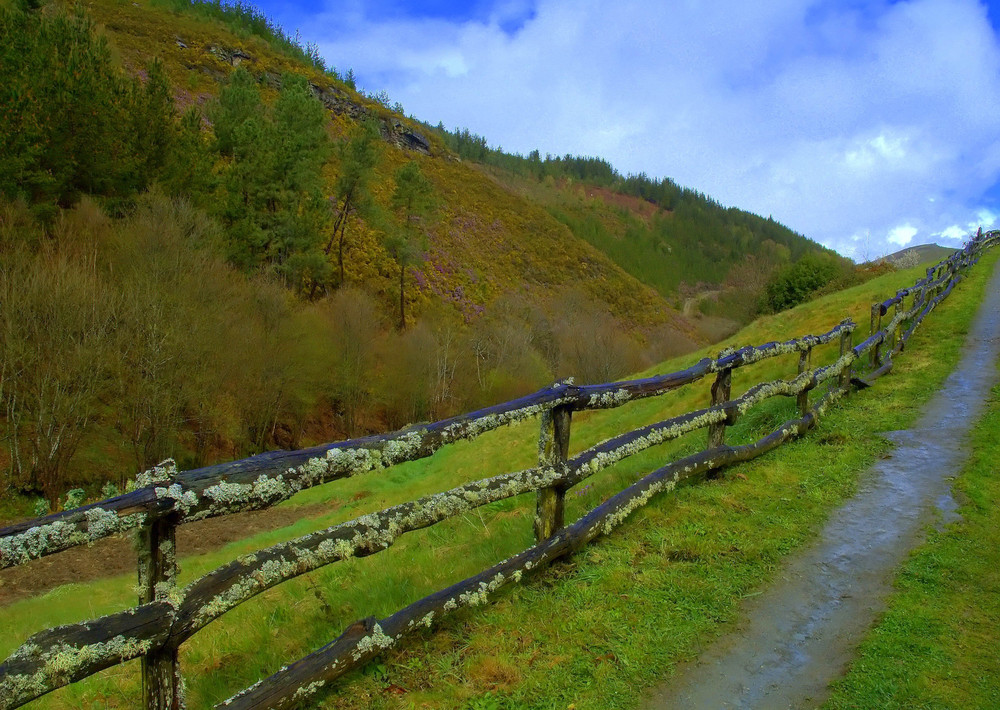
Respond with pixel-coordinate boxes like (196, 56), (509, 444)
(137, 461), (184, 710)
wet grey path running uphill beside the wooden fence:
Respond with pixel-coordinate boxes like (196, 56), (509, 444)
(642, 267), (1000, 710)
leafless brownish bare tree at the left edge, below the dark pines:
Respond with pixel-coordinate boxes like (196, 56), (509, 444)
(0, 239), (122, 505)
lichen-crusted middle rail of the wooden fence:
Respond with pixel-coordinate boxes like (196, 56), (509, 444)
(0, 336), (854, 707)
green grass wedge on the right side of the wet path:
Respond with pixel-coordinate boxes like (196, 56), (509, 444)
(825, 386), (1000, 710)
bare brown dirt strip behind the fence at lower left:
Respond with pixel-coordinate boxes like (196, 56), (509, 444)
(0, 503), (334, 607)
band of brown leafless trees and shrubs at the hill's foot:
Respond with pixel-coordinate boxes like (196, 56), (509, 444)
(0, 193), (687, 508)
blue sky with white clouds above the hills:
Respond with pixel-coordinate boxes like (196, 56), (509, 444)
(252, 0), (1000, 258)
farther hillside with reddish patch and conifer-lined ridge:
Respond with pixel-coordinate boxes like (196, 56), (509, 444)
(434, 138), (843, 308)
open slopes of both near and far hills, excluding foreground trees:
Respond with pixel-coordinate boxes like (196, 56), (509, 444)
(78, 0), (832, 332)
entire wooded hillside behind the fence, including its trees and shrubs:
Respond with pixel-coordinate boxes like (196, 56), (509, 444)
(0, 0), (860, 517)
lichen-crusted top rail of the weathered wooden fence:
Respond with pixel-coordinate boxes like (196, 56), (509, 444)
(0, 325), (842, 569)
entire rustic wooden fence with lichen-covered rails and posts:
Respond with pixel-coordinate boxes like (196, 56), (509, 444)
(0, 231), (1000, 710)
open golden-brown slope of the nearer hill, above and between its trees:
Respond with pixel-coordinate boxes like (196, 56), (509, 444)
(80, 0), (688, 331)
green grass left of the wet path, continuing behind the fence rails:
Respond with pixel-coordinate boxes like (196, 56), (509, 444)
(0, 251), (1000, 710)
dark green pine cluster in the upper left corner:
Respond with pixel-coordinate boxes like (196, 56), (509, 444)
(0, 7), (174, 214)
